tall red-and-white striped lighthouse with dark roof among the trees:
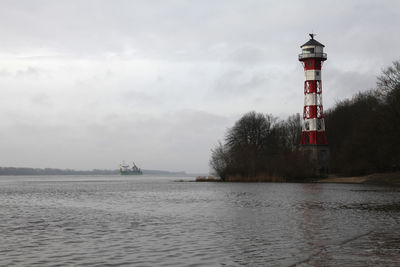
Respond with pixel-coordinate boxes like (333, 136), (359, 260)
(299, 34), (329, 175)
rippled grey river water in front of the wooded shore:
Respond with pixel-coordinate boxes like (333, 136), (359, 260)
(0, 176), (400, 266)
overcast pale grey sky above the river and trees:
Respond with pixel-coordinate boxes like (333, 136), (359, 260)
(0, 0), (400, 173)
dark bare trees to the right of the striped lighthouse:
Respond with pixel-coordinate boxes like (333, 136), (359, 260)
(325, 61), (400, 175)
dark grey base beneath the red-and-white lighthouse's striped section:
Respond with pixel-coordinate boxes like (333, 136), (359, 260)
(300, 145), (329, 177)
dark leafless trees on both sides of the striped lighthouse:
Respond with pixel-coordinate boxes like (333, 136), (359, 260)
(210, 61), (400, 181)
